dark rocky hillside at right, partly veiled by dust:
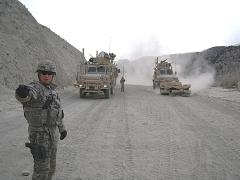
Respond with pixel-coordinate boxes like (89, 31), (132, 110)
(166, 46), (240, 88)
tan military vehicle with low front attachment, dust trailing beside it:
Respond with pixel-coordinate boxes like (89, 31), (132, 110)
(153, 58), (191, 96)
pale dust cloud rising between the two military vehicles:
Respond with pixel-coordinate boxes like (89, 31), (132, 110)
(117, 39), (162, 86)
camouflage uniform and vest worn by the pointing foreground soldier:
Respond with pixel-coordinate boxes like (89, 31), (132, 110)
(16, 82), (65, 180)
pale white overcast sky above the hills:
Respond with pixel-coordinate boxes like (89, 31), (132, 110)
(20, 0), (240, 59)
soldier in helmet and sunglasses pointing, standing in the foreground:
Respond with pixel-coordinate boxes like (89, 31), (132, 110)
(15, 61), (67, 180)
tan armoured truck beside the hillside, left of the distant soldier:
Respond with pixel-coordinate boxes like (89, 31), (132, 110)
(74, 51), (119, 98)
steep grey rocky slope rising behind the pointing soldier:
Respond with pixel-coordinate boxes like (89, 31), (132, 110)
(0, 0), (85, 89)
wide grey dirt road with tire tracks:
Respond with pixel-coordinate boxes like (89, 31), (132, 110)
(0, 86), (240, 180)
